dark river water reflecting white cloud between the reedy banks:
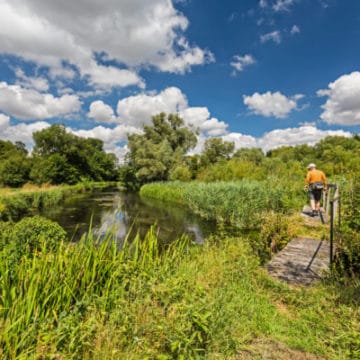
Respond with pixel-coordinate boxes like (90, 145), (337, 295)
(41, 189), (215, 244)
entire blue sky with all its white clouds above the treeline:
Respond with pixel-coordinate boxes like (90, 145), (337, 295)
(0, 0), (360, 158)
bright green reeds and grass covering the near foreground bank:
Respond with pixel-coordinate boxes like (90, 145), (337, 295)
(0, 231), (360, 359)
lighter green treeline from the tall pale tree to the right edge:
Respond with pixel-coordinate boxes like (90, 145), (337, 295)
(120, 113), (360, 189)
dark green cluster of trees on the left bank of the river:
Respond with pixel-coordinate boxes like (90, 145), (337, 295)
(0, 124), (118, 187)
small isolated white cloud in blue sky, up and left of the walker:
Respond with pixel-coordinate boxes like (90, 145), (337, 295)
(243, 91), (302, 118)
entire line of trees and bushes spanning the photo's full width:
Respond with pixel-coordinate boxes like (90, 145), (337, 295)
(0, 113), (360, 190)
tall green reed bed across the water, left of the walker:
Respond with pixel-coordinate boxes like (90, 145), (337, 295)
(140, 180), (289, 229)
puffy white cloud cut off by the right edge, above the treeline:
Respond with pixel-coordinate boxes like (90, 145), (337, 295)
(317, 71), (360, 125)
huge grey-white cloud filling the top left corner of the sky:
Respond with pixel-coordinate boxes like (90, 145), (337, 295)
(0, 0), (213, 87)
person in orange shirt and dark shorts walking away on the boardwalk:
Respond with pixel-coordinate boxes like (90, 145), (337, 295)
(304, 163), (327, 216)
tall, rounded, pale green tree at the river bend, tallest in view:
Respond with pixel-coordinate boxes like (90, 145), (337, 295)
(127, 113), (197, 184)
